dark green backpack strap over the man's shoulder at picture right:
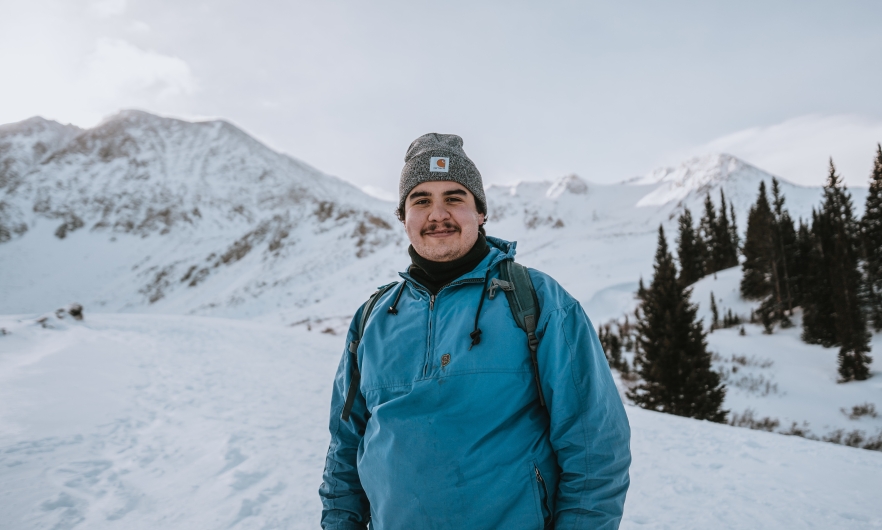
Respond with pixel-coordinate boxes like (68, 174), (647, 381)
(489, 259), (545, 407)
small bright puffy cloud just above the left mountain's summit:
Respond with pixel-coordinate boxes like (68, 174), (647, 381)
(79, 39), (198, 103)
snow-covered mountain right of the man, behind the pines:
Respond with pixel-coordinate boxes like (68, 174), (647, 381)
(487, 154), (866, 322)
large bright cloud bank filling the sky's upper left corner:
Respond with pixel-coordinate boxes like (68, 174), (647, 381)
(0, 0), (201, 127)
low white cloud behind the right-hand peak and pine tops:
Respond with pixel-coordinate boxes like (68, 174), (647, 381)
(689, 114), (882, 187)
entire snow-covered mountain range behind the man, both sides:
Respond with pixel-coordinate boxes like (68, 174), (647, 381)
(0, 111), (864, 325)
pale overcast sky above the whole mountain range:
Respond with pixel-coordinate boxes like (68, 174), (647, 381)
(0, 0), (882, 194)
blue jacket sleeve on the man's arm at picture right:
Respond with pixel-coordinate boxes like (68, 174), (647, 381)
(538, 301), (631, 530)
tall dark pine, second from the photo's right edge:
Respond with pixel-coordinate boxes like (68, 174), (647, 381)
(800, 159), (872, 382)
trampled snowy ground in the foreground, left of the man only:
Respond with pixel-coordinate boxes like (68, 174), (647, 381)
(0, 314), (340, 530)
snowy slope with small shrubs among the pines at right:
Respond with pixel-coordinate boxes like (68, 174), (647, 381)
(692, 267), (882, 438)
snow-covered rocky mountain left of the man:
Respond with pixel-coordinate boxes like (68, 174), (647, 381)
(0, 111), (401, 316)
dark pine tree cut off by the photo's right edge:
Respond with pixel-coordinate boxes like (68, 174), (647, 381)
(861, 144), (882, 331)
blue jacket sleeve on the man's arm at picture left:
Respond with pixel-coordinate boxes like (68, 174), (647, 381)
(319, 306), (370, 530)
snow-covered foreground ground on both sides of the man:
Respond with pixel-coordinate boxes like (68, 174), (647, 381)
(0, 313), (882, 530)
